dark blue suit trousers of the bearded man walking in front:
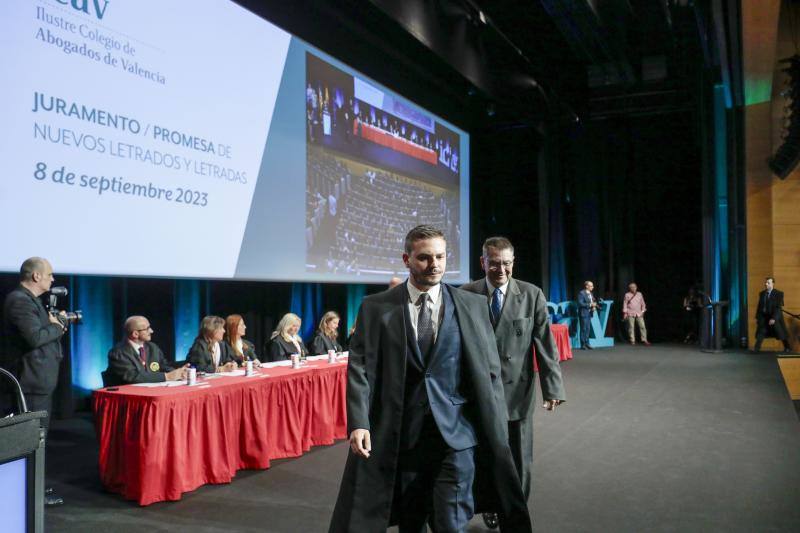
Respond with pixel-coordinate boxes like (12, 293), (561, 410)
(395, 420), (475, 533)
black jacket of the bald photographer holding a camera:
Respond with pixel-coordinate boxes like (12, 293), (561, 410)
(3, 285), (64, 394)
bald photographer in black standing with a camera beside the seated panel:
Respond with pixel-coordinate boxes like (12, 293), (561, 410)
(0, 257), (67, 505)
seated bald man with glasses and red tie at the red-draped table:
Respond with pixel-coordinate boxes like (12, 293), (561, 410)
(105, 316), (188, 386)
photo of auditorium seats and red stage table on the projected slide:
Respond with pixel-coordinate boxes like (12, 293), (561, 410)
(305, 53), (461, 275)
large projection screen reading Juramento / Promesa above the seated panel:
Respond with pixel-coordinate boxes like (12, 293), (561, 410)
(0, 0), (469, 283)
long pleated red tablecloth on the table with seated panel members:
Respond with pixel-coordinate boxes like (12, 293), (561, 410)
(92, 361), (347, 505)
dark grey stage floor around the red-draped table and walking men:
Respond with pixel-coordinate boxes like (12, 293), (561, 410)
(45, 345), (800, 533)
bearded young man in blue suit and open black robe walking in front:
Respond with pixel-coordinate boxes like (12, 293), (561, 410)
(329, 226), (531, 533)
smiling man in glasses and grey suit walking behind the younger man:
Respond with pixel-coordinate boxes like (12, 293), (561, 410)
(461, 237), (565, 528)
